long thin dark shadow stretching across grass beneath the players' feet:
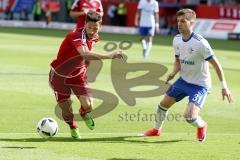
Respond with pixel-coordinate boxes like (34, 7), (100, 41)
(0, 136), (189, 144)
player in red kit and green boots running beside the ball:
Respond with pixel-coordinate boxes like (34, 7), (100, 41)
(49, 11), (124, 138)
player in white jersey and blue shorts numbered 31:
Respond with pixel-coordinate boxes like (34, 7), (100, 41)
(144, 9), (232, 142)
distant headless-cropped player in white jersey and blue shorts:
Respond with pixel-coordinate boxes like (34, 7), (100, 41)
(135, 0), (159, 59)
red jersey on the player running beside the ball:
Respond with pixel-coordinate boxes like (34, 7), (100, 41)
(51, 28), (99, 78)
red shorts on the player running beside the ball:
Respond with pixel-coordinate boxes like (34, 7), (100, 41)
(49, 69), (90, 102)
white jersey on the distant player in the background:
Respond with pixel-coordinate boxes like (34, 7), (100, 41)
(138, 0), (159, 27)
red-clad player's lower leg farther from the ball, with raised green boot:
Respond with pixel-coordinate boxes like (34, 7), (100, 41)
(78, 95), (95, 130)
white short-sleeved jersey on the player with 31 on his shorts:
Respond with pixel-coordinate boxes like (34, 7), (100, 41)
(173, 32), (214, 89)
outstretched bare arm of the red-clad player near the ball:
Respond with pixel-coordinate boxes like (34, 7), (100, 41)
(77, 46), (126, 60)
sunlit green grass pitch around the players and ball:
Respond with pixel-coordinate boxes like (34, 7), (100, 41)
(0, 28), (240, 160)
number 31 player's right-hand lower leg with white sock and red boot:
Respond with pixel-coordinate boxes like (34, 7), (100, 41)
(183, 103), (207, 142)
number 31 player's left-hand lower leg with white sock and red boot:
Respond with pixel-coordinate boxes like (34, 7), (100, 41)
(144, 95), (176, 136)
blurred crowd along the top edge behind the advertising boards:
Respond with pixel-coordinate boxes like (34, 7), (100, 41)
(0, 0), (240, 34)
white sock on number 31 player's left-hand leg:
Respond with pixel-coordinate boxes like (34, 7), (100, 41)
(154, 105), (168, 130)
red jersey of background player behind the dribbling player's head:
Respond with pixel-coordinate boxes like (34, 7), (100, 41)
(71, 0), (103, 28)
